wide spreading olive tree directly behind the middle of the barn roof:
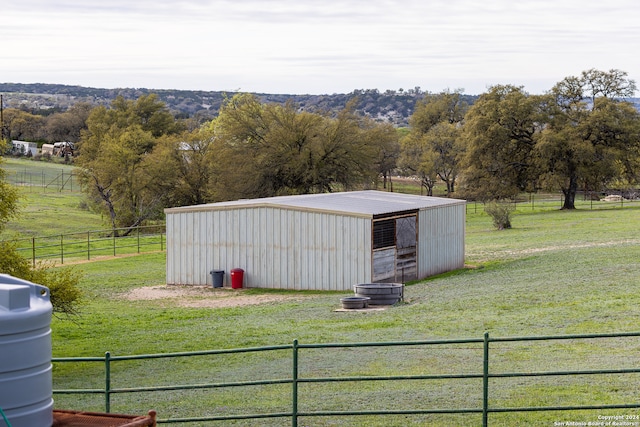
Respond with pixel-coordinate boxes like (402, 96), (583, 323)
(212, 94), (384, 199)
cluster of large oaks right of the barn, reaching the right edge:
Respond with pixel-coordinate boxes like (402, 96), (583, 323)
(400, 69), (640, 209)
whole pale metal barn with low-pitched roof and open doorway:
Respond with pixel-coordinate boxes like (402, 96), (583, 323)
(165, 191), (465, 290)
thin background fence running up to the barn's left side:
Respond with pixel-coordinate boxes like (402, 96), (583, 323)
(9, 224), (166, 265)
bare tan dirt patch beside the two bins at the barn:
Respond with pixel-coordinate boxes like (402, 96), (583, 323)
(123, 285), (304, 308)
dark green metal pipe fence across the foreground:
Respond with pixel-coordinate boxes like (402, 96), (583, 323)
(53, 332), (640, 427)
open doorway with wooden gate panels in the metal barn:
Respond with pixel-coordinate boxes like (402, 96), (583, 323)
(373, 214), (417, 282)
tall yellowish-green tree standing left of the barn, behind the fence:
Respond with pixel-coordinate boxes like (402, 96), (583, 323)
(76, 95), (182, 235)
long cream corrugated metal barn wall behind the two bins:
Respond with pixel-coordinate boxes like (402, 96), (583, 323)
(167, 206), (372, 290)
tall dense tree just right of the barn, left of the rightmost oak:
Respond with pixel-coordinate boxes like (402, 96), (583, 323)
(463, 85), (542, 200)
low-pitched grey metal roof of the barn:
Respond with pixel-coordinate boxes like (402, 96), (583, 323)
(165, 190), (466, 216)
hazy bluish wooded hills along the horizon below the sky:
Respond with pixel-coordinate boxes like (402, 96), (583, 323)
(0, 83), (476, 126)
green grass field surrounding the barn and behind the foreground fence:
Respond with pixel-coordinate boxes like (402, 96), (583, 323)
(3, 159), (640, 426)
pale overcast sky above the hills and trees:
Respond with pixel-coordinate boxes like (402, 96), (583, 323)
(0, 0), (640, 95)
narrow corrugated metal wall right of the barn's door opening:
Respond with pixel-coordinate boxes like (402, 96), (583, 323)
(418, 203), (466, 278)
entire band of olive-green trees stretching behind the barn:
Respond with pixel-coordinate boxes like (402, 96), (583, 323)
(1, 69), (640, 236)
